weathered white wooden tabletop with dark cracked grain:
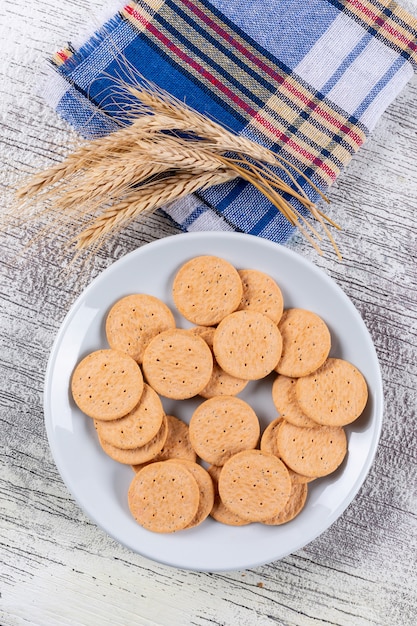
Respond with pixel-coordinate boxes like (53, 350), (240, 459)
(0, 0), (417, 626)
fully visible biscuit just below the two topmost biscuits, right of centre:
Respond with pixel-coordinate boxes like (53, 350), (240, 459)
(213, 311), (282, 380)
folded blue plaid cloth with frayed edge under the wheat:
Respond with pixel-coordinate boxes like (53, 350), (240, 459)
(45, 0), (417, 242)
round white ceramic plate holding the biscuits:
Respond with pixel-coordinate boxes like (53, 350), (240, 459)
(44, 233), (383, 571)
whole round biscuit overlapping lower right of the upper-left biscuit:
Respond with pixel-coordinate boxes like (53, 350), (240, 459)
(142, 329), (213, 400)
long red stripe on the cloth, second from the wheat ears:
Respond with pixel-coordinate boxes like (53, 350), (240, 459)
(179, 0), (363, 147)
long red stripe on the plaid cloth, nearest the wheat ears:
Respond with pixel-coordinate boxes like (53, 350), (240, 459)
(126, 7), (337, 181)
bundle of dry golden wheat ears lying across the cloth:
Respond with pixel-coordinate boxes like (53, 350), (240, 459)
(11, 84), (340, 256)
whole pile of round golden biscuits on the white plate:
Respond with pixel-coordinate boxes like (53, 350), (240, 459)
(71, 255), (368, 533)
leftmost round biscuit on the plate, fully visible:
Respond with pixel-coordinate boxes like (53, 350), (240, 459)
(71, 349), (144, 420)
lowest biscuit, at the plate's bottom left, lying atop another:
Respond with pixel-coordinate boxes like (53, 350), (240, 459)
(128, 461), (200, 533)
